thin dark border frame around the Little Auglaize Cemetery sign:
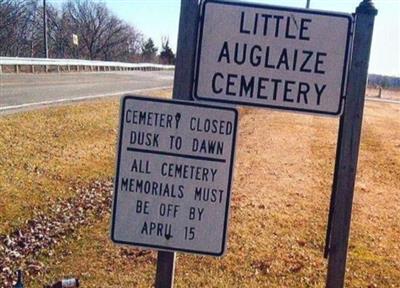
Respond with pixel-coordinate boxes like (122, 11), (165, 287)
(193, 0), (354, 116)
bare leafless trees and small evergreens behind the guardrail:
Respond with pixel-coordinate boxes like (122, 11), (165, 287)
(0, 0), (175, 64)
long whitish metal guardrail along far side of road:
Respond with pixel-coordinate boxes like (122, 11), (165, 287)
(0, 57), (175, 73)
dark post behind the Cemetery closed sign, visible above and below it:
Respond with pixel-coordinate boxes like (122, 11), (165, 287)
(155, 0), (200, 288)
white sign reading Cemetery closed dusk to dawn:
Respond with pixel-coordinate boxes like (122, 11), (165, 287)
(111, 96), (237, 256)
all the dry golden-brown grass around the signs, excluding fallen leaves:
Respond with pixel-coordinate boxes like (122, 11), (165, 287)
(0, 93), (400, 287)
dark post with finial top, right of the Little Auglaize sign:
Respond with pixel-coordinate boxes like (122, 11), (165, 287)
(326, 0), (377, 288)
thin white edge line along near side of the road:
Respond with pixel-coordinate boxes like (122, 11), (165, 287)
(0, 86), (172, 111)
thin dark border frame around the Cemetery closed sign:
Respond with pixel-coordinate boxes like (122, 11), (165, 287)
(110, 95), (238, 256)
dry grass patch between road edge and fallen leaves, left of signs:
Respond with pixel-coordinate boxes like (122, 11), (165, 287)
(0, 91), (170, 234)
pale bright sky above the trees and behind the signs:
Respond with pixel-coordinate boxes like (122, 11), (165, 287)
(48, 0), (400, 76)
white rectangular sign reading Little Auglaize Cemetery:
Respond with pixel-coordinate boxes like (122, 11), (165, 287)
(194, 0), (352, 115)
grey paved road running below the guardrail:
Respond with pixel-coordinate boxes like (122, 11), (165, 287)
(0, 71), (174, 112)
